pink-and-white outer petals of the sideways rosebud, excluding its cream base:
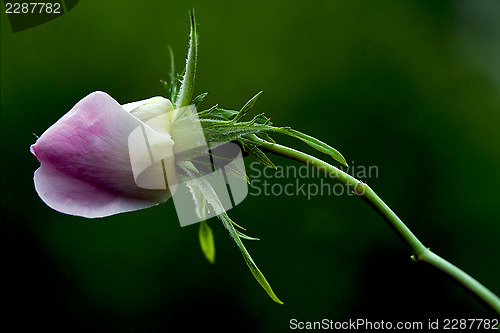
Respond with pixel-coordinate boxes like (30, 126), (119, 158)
(31, 92), (173, 218)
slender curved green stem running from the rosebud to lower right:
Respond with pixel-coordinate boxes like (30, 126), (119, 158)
(258, 139), (500, 316)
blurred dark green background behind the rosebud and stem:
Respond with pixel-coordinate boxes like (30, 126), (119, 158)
(1, 0), (500, 332)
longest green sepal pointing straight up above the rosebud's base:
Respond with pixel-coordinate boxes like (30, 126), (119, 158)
(175, 9), (198, 109)
